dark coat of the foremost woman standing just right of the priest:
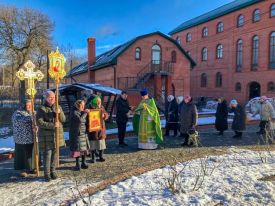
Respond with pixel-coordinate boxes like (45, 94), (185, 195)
(180, 102), (198, 133)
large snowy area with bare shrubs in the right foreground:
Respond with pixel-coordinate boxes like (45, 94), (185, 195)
(73, 148), (275, 206)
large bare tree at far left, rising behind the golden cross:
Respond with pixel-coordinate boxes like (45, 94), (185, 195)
(0, 7), (54, 102)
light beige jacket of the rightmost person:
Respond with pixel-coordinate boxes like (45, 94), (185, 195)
(253, 100), (275, 121)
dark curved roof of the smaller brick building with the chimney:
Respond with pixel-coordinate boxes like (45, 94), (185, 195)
(66, 31), (196, 77)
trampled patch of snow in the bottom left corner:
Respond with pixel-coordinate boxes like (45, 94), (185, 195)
(0, 172), (97, 206)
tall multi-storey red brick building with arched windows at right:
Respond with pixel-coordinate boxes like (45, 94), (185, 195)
(169, 0), (275, 103)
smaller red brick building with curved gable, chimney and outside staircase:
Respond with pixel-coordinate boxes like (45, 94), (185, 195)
(67, 32), (195, 108)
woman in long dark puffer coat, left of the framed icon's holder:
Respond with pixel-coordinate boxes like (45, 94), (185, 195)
(69, 100), (90, 170)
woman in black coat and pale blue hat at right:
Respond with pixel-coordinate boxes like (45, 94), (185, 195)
(229, 99), (246, 138)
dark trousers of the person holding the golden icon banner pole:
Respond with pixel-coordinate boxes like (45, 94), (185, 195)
(43, 149), (56, 176)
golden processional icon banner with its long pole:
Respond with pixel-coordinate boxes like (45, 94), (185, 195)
(48, 48), (66, 168)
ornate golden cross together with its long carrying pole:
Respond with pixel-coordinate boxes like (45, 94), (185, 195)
(16, 60), (44, 177)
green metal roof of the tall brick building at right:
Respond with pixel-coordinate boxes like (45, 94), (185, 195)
(169, 0), (263, 35)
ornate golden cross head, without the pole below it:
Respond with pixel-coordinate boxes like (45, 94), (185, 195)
(16, 60), (44, 97)
